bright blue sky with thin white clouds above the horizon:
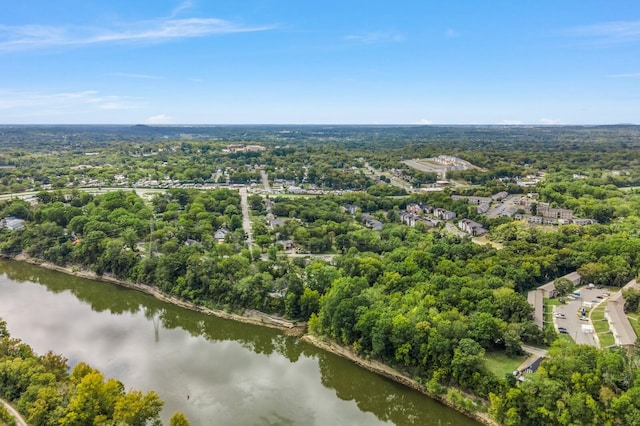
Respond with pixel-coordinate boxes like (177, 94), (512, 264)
(0, 0), (640, 124)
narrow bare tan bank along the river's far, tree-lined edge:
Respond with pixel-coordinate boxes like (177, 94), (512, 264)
(0, 253), (499, 426)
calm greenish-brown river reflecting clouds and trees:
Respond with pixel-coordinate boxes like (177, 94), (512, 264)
(0, 259), (478, 426)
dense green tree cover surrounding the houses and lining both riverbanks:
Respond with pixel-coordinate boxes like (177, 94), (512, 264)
(0, 126), (640, 425)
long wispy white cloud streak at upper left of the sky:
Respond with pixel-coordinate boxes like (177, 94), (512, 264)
(0, 9), (274, 51)
